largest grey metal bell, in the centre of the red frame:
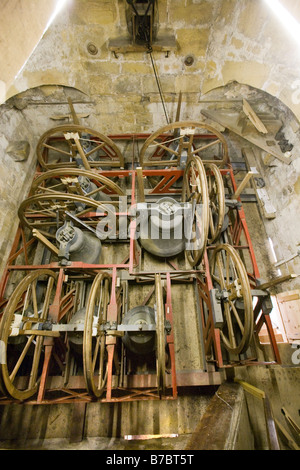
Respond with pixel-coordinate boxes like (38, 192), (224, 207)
(139, 197), (185, 258)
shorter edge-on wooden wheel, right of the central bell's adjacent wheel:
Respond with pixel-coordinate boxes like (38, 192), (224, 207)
(204, 163), (225, 245)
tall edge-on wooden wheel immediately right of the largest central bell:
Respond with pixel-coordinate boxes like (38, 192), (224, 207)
(182, 157), (209, 266)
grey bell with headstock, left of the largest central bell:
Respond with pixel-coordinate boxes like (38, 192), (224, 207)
(56, 220), (101, 265)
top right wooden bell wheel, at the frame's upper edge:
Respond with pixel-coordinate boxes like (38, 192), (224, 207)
(140, 121), (228, 167)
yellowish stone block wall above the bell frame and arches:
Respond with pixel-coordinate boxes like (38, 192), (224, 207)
(3, 0), (300, 125)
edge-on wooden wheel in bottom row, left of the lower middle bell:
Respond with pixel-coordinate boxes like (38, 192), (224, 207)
(83, 273), (111, 398)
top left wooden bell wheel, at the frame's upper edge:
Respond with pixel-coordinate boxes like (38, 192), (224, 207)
(36, 124), (124, 170)
